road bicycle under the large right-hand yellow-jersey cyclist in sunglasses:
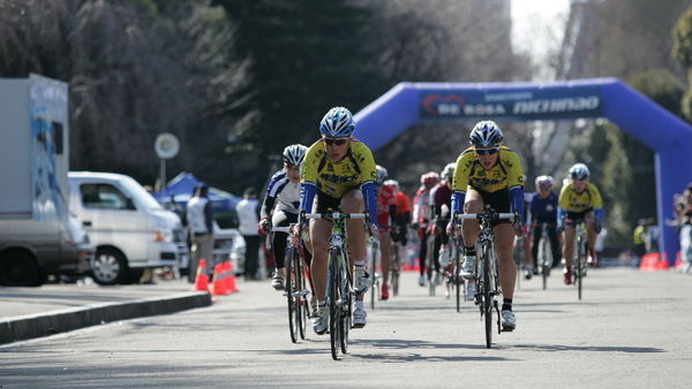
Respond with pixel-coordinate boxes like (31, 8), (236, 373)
(455, 205), (515, 348)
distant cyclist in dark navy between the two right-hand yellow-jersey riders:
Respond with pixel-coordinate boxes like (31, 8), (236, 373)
(530, 176), (560, 268)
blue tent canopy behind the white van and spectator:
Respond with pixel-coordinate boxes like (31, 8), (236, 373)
(154, 172), (242, 212)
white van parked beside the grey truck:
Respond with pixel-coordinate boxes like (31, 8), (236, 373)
(68, 172), (189, 285)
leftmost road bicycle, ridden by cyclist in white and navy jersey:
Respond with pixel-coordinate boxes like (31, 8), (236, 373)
(272, 225), (312, 343)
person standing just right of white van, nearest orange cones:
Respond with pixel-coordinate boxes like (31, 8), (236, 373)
(187, 184), (214, 282)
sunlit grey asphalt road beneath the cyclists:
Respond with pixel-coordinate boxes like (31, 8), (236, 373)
(0, 268), (692, 389)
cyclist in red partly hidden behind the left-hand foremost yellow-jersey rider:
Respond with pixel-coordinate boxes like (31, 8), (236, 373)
(371, 165), (396, 300)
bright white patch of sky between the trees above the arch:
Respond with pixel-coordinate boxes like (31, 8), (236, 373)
(512, 0), (570, 78)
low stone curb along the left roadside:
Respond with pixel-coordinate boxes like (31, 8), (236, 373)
(0, 292), (211, 344)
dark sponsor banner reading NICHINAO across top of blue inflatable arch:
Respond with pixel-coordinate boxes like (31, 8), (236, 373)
(419, 86), (602, 120)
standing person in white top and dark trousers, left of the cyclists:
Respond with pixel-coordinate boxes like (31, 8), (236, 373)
(235, 188), (261, 280)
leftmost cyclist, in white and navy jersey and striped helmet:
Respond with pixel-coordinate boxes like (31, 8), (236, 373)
(258, 144), (310, 290)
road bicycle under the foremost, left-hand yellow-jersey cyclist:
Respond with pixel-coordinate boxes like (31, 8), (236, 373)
(305, 212), (365, 360)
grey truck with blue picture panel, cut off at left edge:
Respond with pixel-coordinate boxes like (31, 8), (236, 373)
(0, 74), (94, 286)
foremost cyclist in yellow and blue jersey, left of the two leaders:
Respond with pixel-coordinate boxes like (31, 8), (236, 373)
(298, 107), (378, 335)
